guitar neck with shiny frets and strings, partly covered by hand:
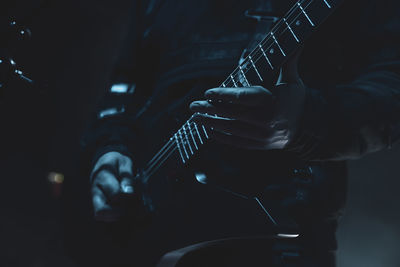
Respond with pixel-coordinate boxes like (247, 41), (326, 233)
(140, 0), (343, 181)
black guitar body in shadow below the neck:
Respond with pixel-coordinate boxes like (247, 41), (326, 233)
(126, 147), (310, 266)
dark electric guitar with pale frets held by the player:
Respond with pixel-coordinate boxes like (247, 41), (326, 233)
(128, 0), (341, 266)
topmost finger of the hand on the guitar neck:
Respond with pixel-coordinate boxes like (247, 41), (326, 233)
(204, 86), (273, 106)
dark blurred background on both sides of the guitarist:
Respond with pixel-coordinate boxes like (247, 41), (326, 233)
(0, 0), (400, 267)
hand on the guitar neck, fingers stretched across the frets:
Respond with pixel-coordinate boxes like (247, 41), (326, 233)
(190, 56), (305, 150)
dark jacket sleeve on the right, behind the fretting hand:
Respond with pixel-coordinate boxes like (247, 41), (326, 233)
(287, 1), (400, 160)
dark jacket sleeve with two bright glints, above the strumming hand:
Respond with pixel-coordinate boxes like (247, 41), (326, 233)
(81, 0), (159, 171)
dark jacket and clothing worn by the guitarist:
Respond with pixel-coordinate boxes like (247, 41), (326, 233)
(79, 0), (400, 266)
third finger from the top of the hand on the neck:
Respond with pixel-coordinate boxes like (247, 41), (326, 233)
(193, 113), (270, 140)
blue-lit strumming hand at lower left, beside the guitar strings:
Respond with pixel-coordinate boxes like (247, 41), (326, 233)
(90, 152), (136, 222)
